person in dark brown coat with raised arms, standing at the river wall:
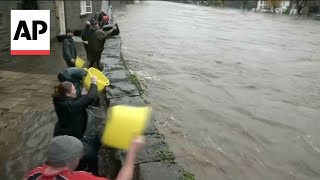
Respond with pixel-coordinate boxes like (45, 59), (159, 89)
(88, 21), (117, 70)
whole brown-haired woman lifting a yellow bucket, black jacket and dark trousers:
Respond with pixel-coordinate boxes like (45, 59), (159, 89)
(53, 76), (101, 175)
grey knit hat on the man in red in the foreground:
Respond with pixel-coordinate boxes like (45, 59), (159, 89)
(47, 135), (83, 167)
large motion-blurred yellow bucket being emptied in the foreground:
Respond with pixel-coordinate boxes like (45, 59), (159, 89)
(102, 105), (151, 150)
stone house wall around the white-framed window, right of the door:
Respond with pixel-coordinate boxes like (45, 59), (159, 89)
(64, 0), (101, 30)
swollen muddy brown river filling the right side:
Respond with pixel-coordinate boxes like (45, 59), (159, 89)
(117, 1), (320, 180)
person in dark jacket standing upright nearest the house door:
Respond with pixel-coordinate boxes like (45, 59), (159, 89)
(62, 29), (77, 67)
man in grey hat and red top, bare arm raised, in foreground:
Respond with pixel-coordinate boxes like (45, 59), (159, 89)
(24, 136), (145, 180)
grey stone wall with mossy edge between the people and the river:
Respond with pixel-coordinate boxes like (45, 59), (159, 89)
(99, 31), (193, 180)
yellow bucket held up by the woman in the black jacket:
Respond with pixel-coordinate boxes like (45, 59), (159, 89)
(83, 67), (110, 92)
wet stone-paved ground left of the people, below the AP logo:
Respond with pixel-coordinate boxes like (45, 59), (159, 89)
(0, 42), (85, 180)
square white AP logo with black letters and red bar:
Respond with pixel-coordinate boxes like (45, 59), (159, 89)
(11, 10), (50, 55)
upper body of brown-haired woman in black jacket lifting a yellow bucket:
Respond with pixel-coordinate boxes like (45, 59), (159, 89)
(52, 76), (98, 139)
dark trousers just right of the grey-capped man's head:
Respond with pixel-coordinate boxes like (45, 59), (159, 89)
(76, 132), (101, 175)
